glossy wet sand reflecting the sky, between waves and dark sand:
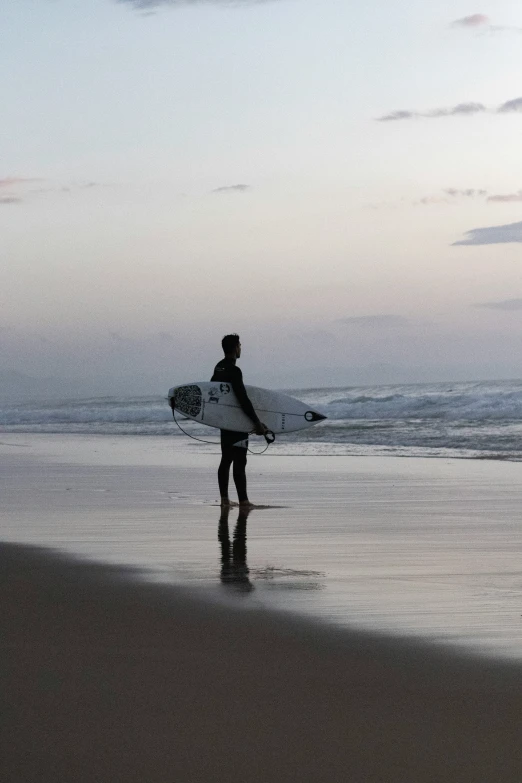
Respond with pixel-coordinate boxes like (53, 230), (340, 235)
(0, 436), (522, 659)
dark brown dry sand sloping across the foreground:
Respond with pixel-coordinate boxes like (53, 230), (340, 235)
(0, 544), (522, 783)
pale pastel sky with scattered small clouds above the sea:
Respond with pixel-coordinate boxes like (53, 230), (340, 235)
(0, 0), (522, 393)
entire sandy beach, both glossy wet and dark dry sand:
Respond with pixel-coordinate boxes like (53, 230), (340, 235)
(0, 435), (522, 783)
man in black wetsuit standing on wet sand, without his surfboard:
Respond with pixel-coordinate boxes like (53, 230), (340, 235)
(210, 334), (267, 508)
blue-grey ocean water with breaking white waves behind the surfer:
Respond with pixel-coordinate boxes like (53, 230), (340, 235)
(0, 380), (522, 461)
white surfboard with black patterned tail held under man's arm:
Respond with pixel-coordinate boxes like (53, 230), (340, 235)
(169, 381), (326, 433)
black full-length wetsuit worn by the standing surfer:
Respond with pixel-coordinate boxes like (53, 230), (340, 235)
(210, 358), (259, 503)
